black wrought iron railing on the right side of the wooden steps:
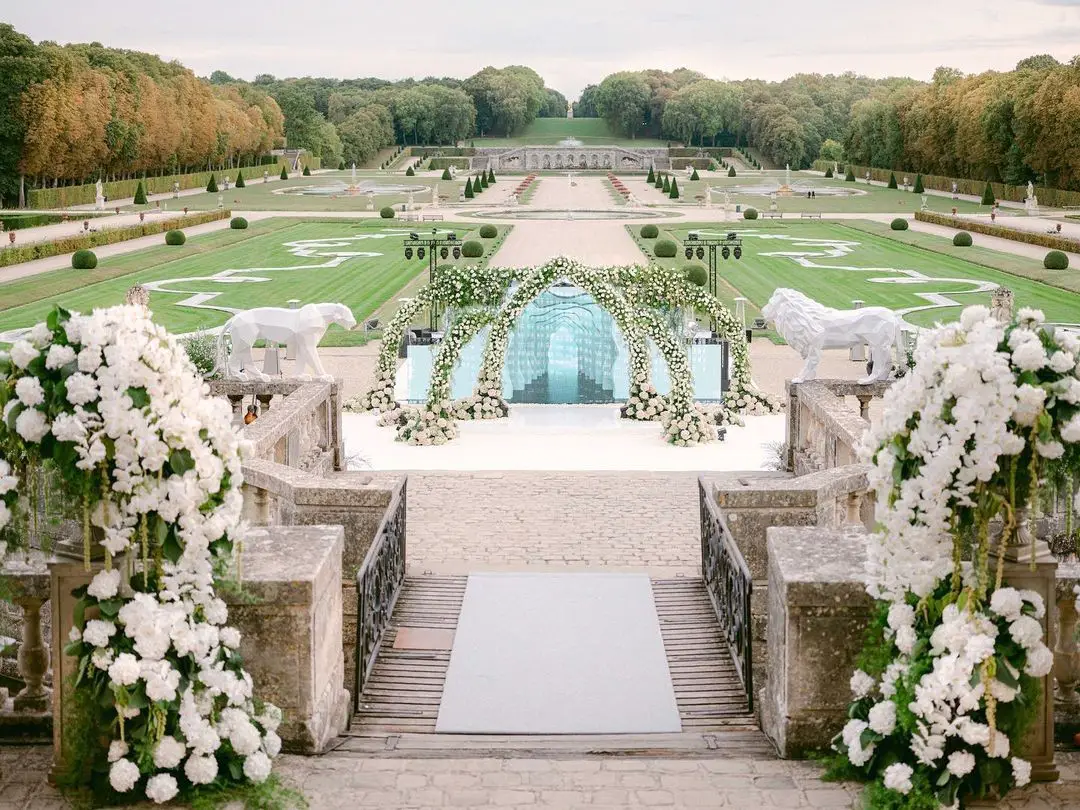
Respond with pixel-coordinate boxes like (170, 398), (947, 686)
(698, 478), (754, 712)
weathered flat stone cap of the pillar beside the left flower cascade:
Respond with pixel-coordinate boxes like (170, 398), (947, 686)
(225, 526), (345, 605)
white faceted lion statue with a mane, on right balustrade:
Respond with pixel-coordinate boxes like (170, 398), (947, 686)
(761, 287), (904, 383)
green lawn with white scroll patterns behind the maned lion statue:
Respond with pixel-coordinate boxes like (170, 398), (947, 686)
(631, 220), (1080, 326)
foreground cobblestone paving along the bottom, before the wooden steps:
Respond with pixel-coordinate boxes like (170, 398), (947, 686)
(0, 746), (1080, 810)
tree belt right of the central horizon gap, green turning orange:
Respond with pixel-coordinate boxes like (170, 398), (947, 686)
(575, 55), (1080, 189)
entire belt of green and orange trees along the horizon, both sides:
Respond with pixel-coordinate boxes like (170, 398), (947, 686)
(0, 17), (1080, 205)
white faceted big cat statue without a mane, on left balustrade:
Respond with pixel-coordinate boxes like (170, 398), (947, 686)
(217, 303), (356, 380)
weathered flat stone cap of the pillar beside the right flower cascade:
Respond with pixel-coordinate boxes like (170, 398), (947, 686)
(767, 526), (873, 607)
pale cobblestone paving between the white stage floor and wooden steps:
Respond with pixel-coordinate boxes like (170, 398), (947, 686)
(408, 472), (701, 576)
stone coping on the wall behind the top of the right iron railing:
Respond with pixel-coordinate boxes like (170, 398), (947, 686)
(712, 464), (870, 509)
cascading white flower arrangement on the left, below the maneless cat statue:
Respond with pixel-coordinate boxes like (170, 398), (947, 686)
(0, 306), (281, 802)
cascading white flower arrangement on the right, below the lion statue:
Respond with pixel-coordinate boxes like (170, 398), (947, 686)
(834, 307), (1080, 810)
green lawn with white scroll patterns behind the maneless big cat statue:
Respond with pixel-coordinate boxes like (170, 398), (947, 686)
(0, 219), (508, 346)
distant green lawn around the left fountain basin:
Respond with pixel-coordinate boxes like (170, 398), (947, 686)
(127, 170), (468, 211)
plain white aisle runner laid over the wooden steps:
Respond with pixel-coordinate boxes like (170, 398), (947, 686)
(435, 573), (681, 734)
